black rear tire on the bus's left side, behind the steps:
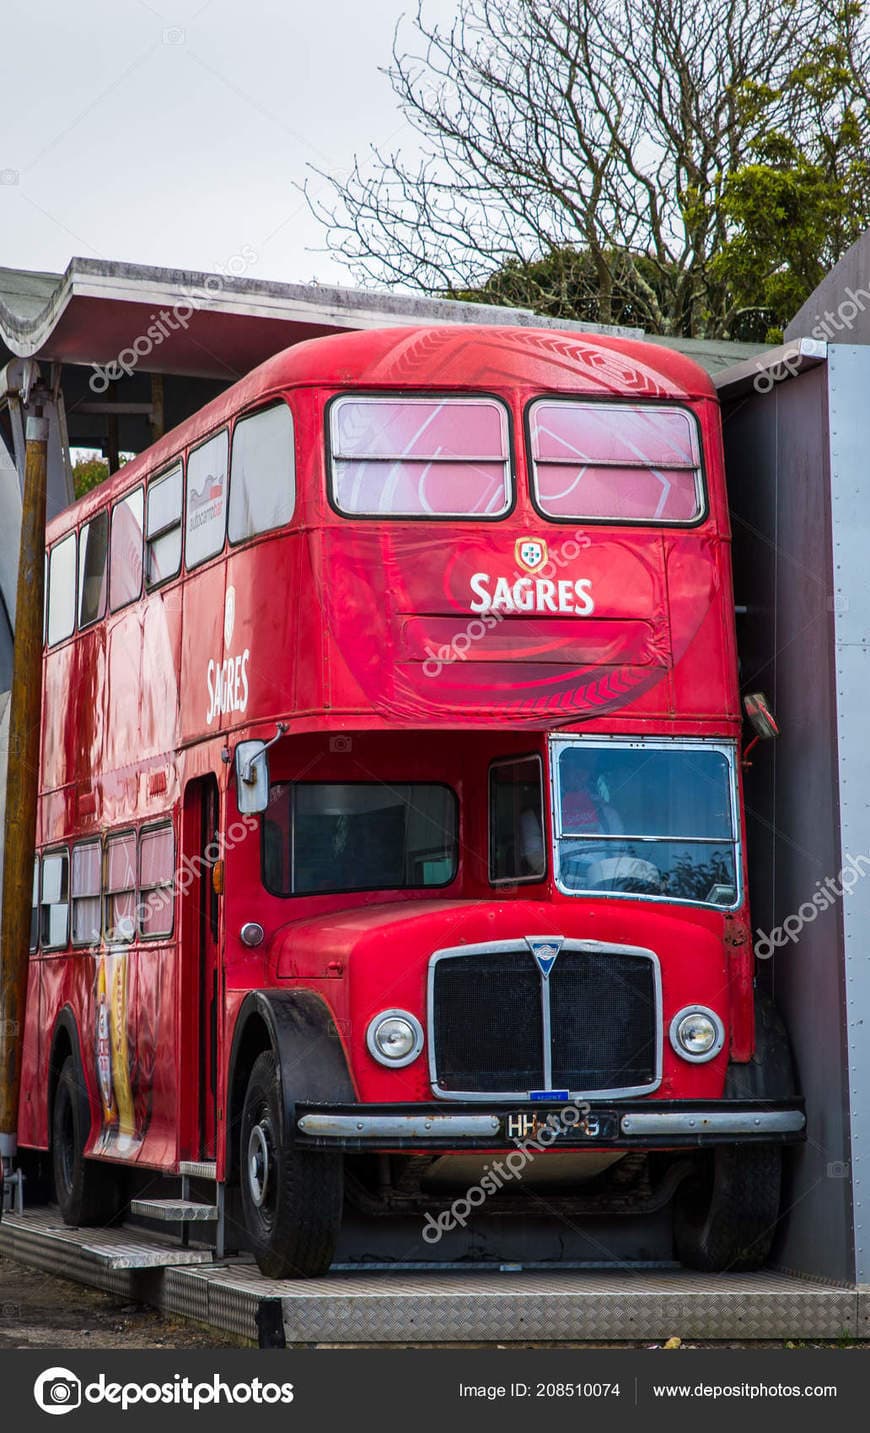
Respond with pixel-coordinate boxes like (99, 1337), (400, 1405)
(52, 1055), (123, 1228)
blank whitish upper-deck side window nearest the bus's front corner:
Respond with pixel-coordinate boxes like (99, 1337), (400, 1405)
(229, 403), (297, 542)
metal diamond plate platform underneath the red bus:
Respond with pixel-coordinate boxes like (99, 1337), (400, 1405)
(0, 1209), (870, 1346)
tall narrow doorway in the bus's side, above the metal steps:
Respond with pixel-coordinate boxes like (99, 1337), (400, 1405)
(182, 775), (221, 1159)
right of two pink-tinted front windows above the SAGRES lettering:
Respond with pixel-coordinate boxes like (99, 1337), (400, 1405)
(529, 398), (704, 524)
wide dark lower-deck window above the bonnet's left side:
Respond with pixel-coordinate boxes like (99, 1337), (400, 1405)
(262, 781), (459, 896)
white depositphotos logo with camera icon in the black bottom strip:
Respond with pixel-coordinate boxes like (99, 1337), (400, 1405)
(33, 1369), (292, 1413)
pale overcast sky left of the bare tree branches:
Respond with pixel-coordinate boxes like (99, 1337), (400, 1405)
(0, 0), (456, 284)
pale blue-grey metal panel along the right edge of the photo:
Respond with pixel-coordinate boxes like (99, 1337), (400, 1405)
(828, 345), (870, 1284)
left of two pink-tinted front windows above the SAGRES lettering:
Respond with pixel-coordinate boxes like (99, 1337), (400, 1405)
(330, 396), (512, 519)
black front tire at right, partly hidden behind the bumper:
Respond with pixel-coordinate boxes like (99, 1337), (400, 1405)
(674, 996), (797, 1274)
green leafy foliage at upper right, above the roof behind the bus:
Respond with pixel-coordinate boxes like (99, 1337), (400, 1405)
(447, 0), (870, 342)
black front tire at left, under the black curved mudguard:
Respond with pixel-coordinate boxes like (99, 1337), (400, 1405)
(239, 1050), (344, 1278)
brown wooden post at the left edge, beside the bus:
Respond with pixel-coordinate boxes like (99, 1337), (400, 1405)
(0, 407), (49, 1159)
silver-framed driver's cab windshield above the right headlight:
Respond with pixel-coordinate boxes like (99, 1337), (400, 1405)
(553, 741), (738, 906)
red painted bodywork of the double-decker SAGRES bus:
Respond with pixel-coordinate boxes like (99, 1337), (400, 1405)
(20, 327), (752, 1186)
